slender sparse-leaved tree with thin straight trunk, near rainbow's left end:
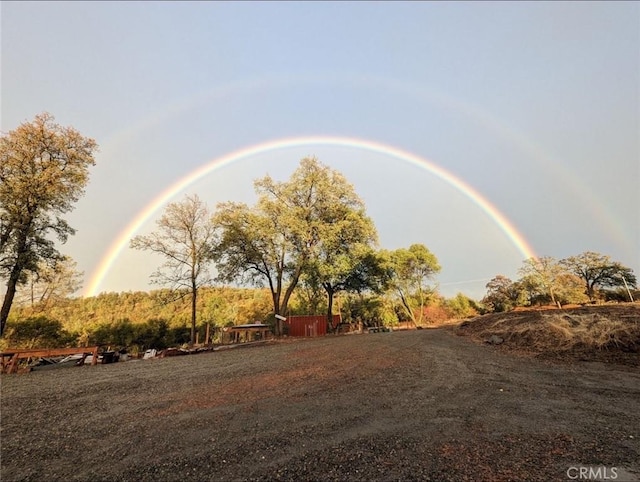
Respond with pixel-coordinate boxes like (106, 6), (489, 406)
(130, 196), (215, 344)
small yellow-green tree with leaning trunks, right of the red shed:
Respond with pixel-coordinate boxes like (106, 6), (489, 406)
(386, 244), (440, 325)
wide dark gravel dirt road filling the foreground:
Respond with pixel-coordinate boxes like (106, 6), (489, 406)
(0, 329), (640, 482)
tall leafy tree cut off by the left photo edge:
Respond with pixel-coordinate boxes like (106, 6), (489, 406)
(0, 113), (97, 335)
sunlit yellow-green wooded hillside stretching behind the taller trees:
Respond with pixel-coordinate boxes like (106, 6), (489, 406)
(0, 286), (480, 352)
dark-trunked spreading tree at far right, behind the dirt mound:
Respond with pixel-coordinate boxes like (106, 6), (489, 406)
(560, 251), (637, 302)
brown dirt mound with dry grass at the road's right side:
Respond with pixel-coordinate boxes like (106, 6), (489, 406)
(455, 303), (640, 366)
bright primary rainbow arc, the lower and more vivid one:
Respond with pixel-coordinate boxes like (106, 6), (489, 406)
(87, 136), (537, 296)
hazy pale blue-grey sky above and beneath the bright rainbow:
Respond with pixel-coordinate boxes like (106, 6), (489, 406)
(0, 1), (640, 298)
